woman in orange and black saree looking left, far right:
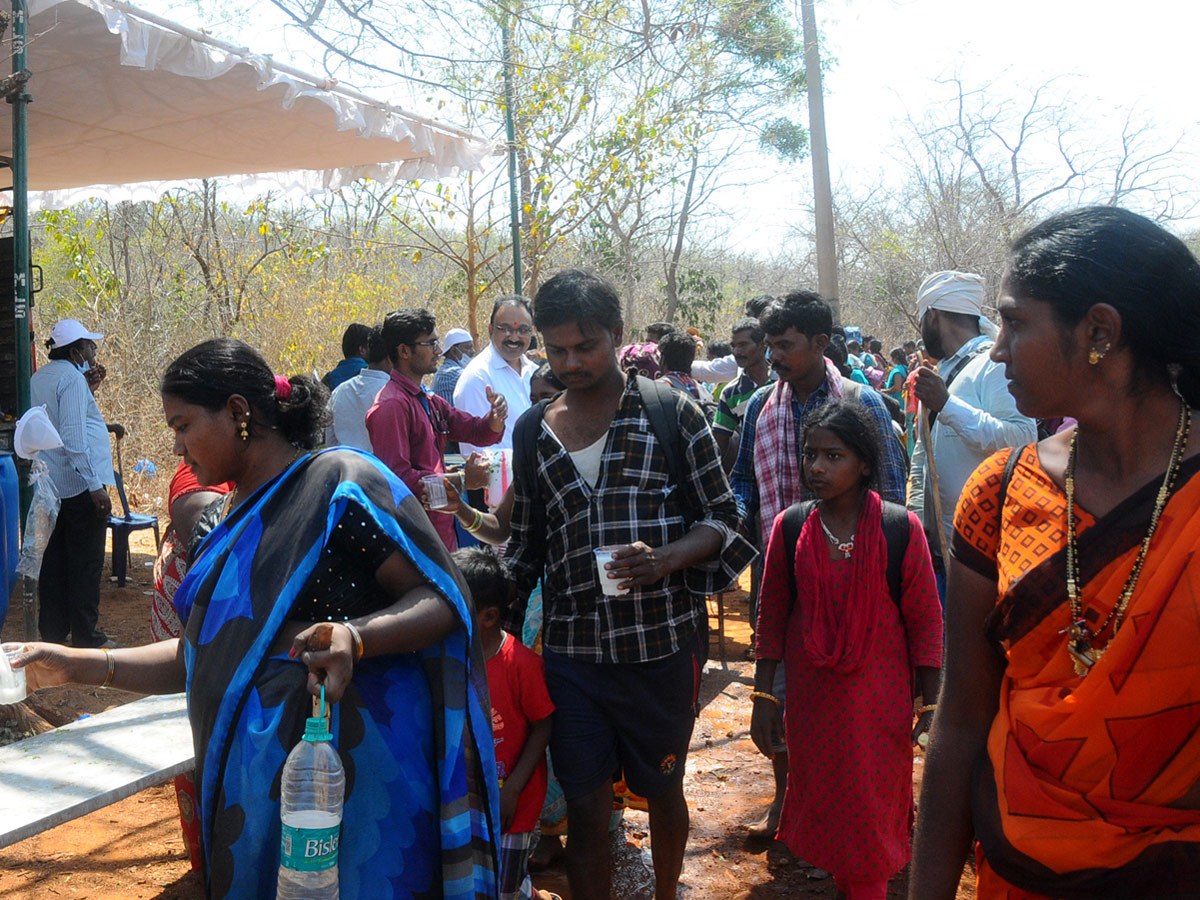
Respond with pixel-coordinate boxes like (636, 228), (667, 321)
(910, 208), (1200, 900)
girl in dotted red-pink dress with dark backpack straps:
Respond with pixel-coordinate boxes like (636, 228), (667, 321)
(751, 401), (942, 900)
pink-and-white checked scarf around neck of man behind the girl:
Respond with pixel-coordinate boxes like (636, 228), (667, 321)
(754, 359), (844, 541)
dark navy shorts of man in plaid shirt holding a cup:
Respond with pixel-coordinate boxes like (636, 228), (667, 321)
(542, 635), (707, 800)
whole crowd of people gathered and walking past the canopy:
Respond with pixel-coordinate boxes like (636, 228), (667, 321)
(13, 208), (1200, 900)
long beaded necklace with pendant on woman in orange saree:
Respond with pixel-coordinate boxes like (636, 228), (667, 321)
(1060, 402), (1192, 678)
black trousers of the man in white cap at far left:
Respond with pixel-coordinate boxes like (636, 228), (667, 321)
(37, 491), (108, 647)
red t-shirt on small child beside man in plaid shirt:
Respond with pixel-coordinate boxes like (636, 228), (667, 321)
(487, 634), (554, 834)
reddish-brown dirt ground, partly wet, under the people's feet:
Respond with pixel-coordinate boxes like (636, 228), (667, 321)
(0, 532), (974, 900)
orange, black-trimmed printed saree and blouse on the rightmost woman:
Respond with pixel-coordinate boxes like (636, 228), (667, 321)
(952, 445), (1200, 900)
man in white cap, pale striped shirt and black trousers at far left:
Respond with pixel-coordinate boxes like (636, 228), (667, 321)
(29, 319), (125, 647)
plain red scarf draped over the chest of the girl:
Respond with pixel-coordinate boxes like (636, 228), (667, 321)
(792, 491), (888, 674)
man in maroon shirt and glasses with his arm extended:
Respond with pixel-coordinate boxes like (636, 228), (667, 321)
(367, 310), (509, 550)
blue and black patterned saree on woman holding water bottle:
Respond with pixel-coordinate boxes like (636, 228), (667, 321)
(175, 450), (499, 900)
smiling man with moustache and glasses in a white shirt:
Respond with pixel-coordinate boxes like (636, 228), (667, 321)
(454, 294), (538, 456)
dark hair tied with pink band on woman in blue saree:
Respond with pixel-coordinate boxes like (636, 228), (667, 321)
(158, 337), (330, 450)
